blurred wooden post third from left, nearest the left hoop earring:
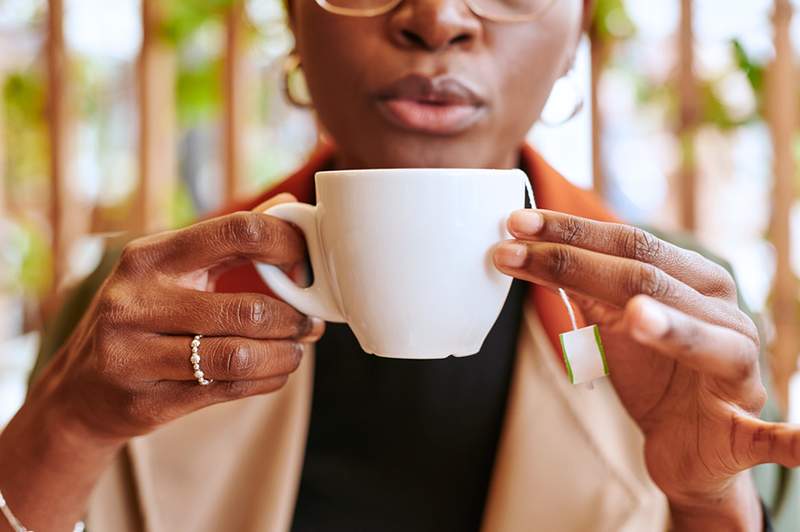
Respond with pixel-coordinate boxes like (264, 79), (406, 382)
(222, 0), (247, 204)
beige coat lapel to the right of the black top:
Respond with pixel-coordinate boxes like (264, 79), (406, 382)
(482, 301), (667, 532)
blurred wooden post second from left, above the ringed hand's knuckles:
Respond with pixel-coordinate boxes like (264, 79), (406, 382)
(135, 0), (177, 232)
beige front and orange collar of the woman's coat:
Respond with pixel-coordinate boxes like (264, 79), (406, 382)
(88, 148), (668, 532)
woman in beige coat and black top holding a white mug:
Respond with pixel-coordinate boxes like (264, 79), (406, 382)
(0, 0), (800, 531)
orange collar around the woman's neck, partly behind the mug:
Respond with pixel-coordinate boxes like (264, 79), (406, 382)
(216, 144), (618, 360)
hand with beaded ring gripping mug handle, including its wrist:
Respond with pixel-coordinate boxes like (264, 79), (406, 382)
(0, 196), (324, 530)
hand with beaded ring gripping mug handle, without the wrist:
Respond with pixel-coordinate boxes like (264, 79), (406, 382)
(43, 195), (324, 439)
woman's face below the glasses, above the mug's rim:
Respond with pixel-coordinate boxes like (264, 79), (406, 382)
(291, 0), (583, 168)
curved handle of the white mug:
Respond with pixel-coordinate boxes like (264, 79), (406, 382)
(254, 203), (346, 323)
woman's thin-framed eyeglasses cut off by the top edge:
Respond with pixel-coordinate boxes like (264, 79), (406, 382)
(316, 0), (557, 22)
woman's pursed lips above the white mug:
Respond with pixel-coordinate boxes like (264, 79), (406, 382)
(378, 74), (485, 135)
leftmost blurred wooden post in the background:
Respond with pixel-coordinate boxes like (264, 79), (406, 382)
(46, 0), (72, 292)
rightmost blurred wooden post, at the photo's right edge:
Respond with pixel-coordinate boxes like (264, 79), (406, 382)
(766, 0), (800, 406)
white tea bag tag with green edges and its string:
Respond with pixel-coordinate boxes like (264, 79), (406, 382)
(525, 179), (609, 390)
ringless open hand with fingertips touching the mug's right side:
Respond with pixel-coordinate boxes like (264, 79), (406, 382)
(495, 210), (800, 530)
